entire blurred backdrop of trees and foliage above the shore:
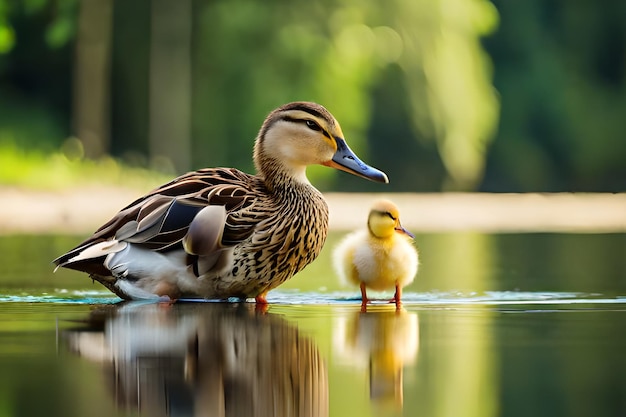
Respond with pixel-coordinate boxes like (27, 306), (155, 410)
(0, 0), (626, 192)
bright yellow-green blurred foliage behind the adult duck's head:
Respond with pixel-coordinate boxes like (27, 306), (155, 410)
(185, 0), (497, 190)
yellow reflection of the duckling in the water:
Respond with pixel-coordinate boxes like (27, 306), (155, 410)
(334, 307), (419, 409)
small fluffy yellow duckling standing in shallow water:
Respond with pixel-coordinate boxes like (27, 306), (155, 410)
(333, 199), (419, 307)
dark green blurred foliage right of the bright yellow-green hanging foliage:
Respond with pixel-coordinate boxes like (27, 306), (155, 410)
(482, 0), (626, 191)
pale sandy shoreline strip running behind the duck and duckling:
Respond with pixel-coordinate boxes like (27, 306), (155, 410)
(0, 186), (626, 235)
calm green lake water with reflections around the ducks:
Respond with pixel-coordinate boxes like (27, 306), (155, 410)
(0, 233), (626, 417)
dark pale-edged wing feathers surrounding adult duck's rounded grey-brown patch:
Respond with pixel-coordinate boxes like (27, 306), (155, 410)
(54, 168), (266, 265)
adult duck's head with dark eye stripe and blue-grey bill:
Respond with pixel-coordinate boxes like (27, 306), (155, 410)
(254, 102), (389, 183)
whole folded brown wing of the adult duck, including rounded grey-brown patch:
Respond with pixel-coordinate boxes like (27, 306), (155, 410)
(53, 168), (264, 272)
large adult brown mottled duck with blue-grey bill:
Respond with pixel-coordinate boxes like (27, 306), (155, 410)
(53, 101), (389, 304)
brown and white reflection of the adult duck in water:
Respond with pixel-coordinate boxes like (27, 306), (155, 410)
(67, 303), (328, 417)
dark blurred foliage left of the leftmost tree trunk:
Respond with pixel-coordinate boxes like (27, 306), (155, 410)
(0, 0), (77, 154)
